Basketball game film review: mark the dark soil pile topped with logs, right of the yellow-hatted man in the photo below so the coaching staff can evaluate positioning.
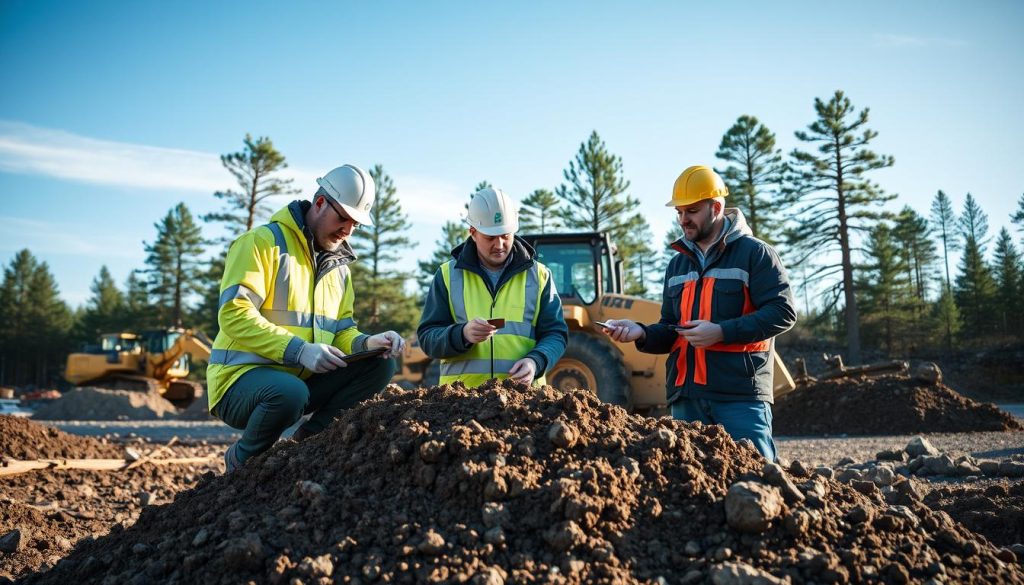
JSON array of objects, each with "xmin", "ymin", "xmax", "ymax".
[{"xmin": 772, "ymin": 376, "xmax": 1022, "ymax": 435}]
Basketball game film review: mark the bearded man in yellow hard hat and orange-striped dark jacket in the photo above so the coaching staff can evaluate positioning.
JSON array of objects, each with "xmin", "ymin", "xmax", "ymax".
[{"xmin": 593, "ymin": 165, "xmax": 797, "ymax": 460}]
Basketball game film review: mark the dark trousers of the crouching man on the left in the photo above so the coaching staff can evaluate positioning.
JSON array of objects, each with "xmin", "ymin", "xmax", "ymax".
[{"xmin": 212, "ymin": 359, "xmax": 395, "ymax": 464}]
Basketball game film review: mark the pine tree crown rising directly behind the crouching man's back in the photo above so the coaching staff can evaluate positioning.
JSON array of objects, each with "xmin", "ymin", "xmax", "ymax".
[{"xmin": 202, "ymin": 134, "xmax": 299, "ymax": 243}]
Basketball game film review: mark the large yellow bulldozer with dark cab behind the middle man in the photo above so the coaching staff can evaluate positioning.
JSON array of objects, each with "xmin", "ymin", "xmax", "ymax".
[{"xmin": 394, "ymin": 233, "xmax": 795, "ymax": 414}]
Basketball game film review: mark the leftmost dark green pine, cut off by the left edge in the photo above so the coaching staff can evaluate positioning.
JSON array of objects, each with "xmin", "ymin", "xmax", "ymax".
[{"xmin": 0, "ymin": 250, "xmax": 73, "ymax": 385}]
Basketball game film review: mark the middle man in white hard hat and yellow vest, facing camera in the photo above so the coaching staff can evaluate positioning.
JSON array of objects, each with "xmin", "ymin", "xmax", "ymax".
[{"xmin": 416, "ymin": 187, "xmax": 568, "ymax": 386}]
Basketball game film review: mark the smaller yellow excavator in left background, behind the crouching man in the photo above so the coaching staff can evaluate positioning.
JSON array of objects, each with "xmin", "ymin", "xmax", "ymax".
[{"xmin": 65, "ymin": 328, "xmax": 213, "ymax": 408}]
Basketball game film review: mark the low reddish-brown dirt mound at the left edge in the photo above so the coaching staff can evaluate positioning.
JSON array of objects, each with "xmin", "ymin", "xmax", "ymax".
[{"xmin": 0, "ymin": 415, "xmax": 124, "ymax": 459}]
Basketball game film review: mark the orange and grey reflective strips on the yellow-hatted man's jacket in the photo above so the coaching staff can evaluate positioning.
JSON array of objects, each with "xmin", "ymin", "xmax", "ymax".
[{"xmin": 669, "ymin": 268, "xmax": 771, "ymax": 386}]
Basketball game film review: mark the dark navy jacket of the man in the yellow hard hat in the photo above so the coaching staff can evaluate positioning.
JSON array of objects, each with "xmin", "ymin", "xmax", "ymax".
[{"xmin": 636, "ymin": 209, "xmax": 797, "ymax": 403}]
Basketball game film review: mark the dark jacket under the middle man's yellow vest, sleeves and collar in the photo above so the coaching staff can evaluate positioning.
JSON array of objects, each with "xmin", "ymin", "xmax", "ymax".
[{"xmin": 416, "ymin": 237, "xmax": 569, "ymax": 377}]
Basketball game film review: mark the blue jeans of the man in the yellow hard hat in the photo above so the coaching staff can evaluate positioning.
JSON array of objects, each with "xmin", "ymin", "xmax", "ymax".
[{"xmin": 672, "ymin": 399, "xmax": 778, "ymax": 461}]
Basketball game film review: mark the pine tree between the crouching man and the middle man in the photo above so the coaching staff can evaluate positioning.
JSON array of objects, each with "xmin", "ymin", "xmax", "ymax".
[{"xmin": 351, "ymin": 165, "xmax": 419, "ymax": 334}]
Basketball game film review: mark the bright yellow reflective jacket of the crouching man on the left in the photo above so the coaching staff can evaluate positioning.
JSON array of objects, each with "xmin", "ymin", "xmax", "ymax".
[{"xmin": 206, "ymin": 207, "xmax": 362, "ymax": 409}]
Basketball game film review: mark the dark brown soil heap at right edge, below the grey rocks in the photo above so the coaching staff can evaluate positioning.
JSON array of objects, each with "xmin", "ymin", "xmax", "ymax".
[{"xmin": 924, "ymin": 482, "xmax": 1024, "ymax": 546}]
